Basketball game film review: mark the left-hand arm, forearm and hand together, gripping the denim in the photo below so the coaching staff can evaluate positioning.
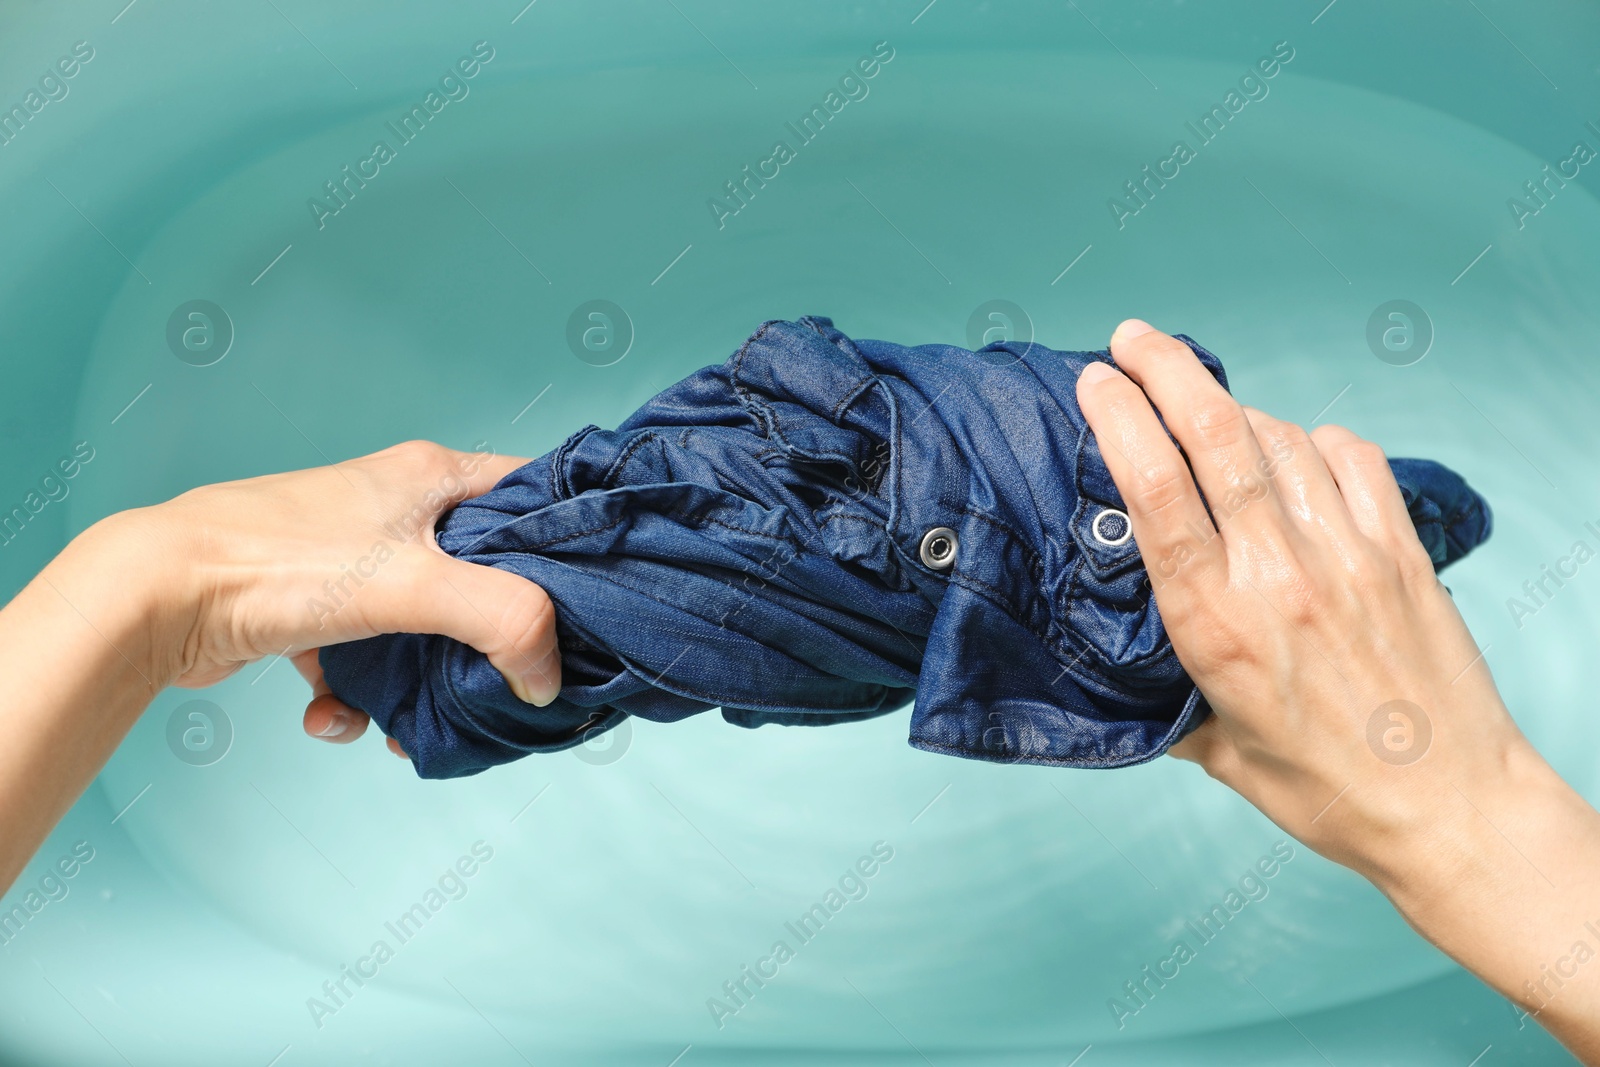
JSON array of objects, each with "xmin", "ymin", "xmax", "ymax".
[{"xmin": 0, "ymin": 442, "xmax": 560, "ymax": 891}]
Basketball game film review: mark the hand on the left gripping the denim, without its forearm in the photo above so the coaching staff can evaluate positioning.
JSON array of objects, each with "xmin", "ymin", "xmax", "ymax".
[{"xmin": 136, "ymin": 442, "xmax": 562, "ymax": 755}]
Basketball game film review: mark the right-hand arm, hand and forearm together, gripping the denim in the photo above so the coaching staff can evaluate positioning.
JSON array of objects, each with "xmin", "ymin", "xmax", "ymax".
[{"xmin": 1078, "ymin": 320, "xmax": 1600, "ymax": 1062}]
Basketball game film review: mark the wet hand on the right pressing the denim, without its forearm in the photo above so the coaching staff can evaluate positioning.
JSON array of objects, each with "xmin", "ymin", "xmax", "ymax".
[{"xmin": 1078, "ymin": 322, "xmax": 1526, "ymax": 869}]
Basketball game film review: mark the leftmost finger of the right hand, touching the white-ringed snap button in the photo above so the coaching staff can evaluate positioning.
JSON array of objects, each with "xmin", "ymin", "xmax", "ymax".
[{"xmin": 1078, "ymin": 362, "xmax": 1224, "ymax": 589}]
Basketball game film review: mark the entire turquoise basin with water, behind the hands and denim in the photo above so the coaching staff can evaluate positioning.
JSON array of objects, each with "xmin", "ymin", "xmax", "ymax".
[{"xmin": 0, "ymin": 0, "xmax": 1600, "ymax": 1067}]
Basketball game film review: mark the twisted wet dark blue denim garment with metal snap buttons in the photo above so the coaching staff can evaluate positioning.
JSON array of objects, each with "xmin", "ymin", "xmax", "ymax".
[{"xmin": 322, "ymin": 318, "xmax": 1491, "ymax": 777}]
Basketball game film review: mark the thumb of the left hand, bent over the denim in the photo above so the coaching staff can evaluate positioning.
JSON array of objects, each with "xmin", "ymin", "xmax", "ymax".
[{"xmin": 352, "ymin": 545, "xmax": 562, "ymax": 707}]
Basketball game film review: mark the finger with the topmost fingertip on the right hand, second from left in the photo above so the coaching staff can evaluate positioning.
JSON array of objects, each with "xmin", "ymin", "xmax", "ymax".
[{"xmin": 1110, "ymin": 318, "xmax": 1282, "ymax": 541}]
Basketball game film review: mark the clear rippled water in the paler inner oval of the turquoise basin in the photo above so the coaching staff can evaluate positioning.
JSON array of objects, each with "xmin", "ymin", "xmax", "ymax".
[{"xmin": 0, "ymin": 20, "xmax": 1600, "ymax": 1049}]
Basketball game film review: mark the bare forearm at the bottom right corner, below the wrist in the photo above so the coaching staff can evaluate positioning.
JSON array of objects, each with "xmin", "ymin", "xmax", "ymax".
[{"xmin": 1362, "ymin": 747, "xmax": 1600, "ymax": 1064}]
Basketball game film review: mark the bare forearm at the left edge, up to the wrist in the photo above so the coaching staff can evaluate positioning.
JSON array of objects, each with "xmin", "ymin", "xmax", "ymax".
[{"xmin": 0, "ymin": 515, "xmax": 174, "ymax": 891}]
